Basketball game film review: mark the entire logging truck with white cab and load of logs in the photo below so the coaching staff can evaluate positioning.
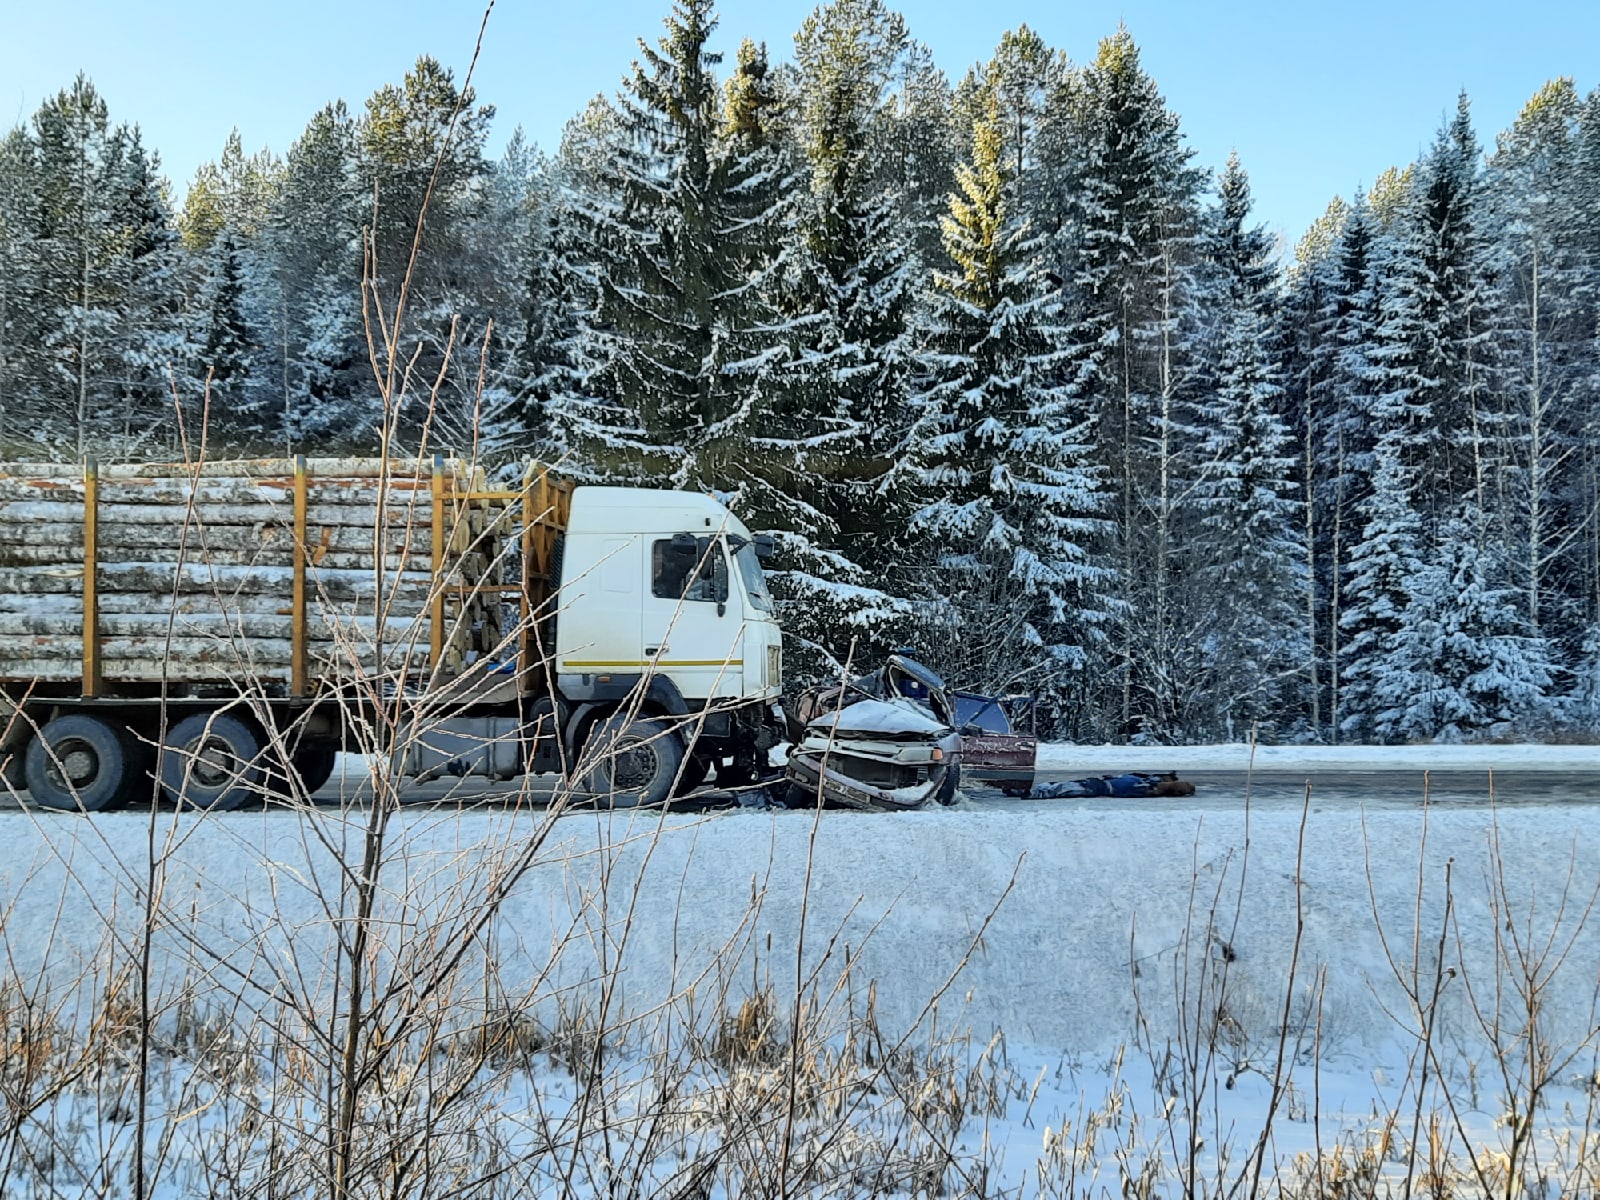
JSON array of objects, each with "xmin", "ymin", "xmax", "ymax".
[{"xmin": 0, "ymin": 458, "xmax": 782, "ymax": 811}]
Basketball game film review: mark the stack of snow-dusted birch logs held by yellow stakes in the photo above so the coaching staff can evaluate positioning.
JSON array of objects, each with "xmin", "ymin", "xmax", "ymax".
[{"xmin": 0, "ymin": 459, "xmax": 515, "ymax": 686}]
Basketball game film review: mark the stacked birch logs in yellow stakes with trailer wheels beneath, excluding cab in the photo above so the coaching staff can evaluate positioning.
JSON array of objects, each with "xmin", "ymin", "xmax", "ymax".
[{"xmin": 0, "ymin": 458, "xmax": 573, "ymax": 810}]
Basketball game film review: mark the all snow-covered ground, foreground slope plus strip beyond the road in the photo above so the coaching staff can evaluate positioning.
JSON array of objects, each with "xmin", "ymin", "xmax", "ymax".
[{"xmin": 0, "ymin": 747, "xmax": 1600, "ymax": 1197}]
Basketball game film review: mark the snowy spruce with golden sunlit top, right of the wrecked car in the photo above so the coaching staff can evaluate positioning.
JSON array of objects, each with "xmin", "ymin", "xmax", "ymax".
[{"xmin": 912, "ymin": 85, "xmax": 1099, "ymax": 702}]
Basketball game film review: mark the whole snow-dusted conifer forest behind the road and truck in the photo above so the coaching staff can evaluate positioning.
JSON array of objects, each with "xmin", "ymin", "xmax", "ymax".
[{"xmin": 0, "ymin": 0, "xmax": 1600, "ymax": 741}]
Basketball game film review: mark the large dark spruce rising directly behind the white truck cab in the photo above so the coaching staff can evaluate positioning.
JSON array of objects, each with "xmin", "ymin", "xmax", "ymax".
[{"xmin": 570, "ymin": 0, "xmax": 782, "ymax": 490}]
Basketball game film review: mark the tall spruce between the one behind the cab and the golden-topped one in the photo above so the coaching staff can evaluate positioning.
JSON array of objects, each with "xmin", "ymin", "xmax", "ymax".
[{"xmin": 763, "ymin": 0, "xmax": 917, "ymax": 677}]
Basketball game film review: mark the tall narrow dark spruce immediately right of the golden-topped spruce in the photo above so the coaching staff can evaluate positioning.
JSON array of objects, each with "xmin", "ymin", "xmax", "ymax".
[{"xmin": 1058, "ymin": 29, "xmax": 1200, "ymax": 738}]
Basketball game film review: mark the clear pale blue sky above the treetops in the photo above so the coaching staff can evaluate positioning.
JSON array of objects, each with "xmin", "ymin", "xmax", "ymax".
[{"xmin": 0, "ymin": 0, "xmax": 1600, "ymax": 243}]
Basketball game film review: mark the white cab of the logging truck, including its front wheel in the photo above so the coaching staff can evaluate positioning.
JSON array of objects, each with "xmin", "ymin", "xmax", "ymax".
[{"xmin": 492, "ymin": 486, "xmax": 782, "ymax": 805}]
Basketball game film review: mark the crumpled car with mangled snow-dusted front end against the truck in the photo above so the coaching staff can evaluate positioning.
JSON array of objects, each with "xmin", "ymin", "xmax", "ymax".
[{"xmin": 784, "ymin": 654, "xmax": 962, "ymax": 811}]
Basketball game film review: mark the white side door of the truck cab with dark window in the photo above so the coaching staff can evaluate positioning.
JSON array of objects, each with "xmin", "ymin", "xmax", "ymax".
[{"xmin": 643, "ymin": 533, "xmax": 744, "ymax": 699}]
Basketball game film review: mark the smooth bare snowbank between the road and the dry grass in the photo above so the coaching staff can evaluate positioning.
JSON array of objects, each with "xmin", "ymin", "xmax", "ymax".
[{"xmin": 0, "ymin": 802, "xmax": 1600, "ymax": 1053}]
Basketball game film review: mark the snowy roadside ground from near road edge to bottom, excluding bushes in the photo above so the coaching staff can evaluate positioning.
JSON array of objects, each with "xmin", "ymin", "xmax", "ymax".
[{"xmin": 0, "ymin": 780, "xmax": 1600, "ymax": 1197}]
